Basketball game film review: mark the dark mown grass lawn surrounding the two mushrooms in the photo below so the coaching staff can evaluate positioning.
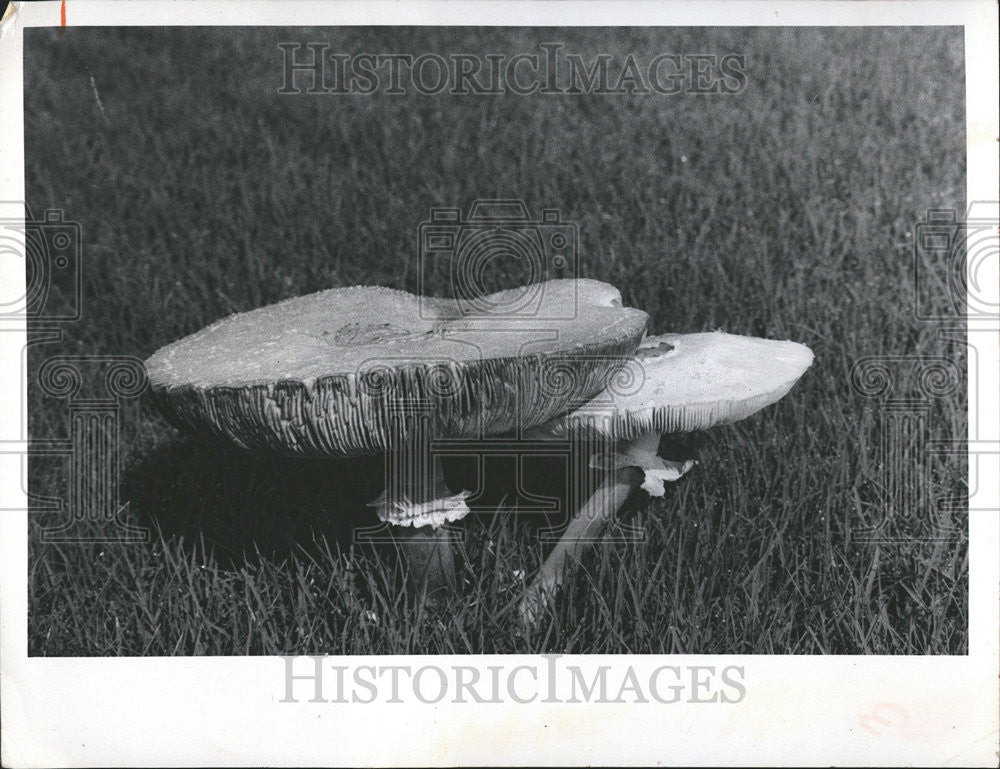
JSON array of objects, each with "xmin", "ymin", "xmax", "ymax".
[{"xmin": 25, "ymin": 28, "xmax": 968, "ymax": 655}]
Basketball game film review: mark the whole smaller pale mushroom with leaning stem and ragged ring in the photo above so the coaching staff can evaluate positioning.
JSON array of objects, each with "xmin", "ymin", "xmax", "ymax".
[{"xmin": 520, "ymin": 332, "xmax": 813, "ymax": 628}]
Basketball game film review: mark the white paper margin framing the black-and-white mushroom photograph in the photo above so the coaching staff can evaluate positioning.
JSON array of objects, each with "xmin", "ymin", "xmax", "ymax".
[{"xmin": 0, "ymin": 0, "xmax": 1000, "ymax": 767}]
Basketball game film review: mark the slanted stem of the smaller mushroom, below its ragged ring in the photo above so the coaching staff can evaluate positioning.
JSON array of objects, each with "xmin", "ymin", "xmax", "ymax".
[{"xmin": 520, "ymin": 467, "xmax": 643, "ymax": 628}]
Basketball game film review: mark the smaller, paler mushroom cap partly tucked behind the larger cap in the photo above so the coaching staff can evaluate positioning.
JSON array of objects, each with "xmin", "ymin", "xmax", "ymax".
[{"xmin": 539, "ymin": 332, "xmax": 813, "ymax": 440}]
